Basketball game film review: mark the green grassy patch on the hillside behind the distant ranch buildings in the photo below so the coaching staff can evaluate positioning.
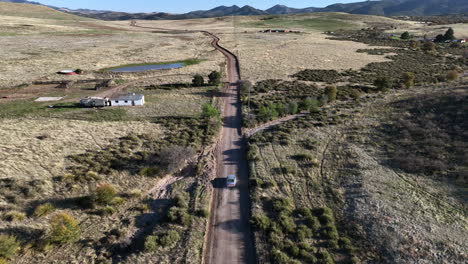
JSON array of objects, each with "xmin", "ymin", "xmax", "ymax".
[{"xmin": 243, "ymin": 15, "xmax": 356, "ymax": 31}]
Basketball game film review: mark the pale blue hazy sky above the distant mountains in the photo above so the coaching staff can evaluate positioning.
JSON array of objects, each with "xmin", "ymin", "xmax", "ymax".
[{"xmin": 33, "ymin": 0, "xmax": 362, "ymax": 13}]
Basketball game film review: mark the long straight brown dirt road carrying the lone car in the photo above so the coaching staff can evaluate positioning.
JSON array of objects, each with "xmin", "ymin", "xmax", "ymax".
[{"xmin": 205, "ymin": 32, "xmax": 255, "ymax": 264}]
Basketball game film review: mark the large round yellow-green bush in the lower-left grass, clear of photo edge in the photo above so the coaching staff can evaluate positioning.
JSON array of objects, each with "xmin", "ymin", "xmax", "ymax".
[{"xmin": 49, "ymin": 213, "xmax": 81, "ymax": 244}]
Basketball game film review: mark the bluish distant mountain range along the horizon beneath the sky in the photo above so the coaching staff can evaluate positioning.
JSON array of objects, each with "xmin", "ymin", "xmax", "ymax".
[{"xmin": 0, "ymin": 0, "xmax": 468, "ymax": 20}]
